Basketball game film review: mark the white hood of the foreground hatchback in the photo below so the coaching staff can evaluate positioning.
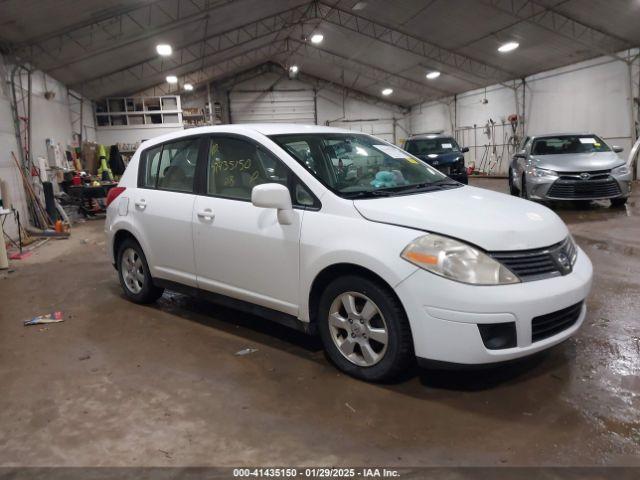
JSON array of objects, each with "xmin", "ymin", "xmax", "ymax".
[{"xmin": 354, "ymin": 186, "xmax": 568, "ymax": 251}]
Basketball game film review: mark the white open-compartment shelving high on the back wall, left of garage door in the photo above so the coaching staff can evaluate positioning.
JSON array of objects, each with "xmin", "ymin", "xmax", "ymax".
[{"xmin": 96, "ymin": 95, "xmax": 183, "ymax": 127}]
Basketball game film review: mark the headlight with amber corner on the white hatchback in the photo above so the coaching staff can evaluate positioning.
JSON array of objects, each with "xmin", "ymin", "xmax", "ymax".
[{"xmin": 400, "ymin": 233, "xmax": 520, "ymax": 285}]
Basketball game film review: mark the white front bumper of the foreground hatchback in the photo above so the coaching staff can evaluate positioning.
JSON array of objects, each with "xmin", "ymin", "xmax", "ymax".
[{"xmin": 395, "ymin": 249, "xmax": 593, "ymax": 365}]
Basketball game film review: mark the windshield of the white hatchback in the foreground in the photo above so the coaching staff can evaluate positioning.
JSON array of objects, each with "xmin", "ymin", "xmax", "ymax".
[{"xmin": 270, "ymin": 133, "xmax": 452, "ymax": 197}]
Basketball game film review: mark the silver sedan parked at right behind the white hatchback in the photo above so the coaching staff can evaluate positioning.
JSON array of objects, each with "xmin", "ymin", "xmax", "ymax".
[{"xmin": 509, "ymin": 133, "xmax": 631, "ymax": 206}]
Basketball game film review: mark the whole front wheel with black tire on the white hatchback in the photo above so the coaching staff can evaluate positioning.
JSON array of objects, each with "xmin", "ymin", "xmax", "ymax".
[{"xmin": 318, "ymin": 275, "xmax": 414, "ymax": 382}]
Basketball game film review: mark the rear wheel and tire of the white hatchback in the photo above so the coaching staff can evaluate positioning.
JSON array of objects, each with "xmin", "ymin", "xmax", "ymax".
[{"xmin": 116, "ymin": 238, "xmax": 164, "ymax": 304}]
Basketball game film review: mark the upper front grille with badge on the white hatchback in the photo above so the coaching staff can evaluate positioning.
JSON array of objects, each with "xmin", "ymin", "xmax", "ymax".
[{"xmin": 490, "ymin": 237, "xmax": 576, "ymax": 282}]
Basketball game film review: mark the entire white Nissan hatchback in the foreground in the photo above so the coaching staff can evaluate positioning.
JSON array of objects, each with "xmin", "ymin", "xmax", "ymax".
[{"xmin": 106, "ymin": 124, "xmax": 592, "ymax": 380}]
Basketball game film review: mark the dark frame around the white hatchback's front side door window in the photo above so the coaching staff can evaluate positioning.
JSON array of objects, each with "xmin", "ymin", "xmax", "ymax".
[{"xmin": 195, "ymin": 132, "xmax": 322, "ymax": 211}]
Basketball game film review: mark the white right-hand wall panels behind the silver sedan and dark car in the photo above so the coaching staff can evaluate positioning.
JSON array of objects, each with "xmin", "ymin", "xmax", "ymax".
[{"xmin": 408, "ymin": 50, "xmax": 640, "ymax": 175}]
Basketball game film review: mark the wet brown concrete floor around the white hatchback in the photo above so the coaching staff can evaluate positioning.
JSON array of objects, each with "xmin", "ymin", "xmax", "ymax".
[{"xmin": 0, "ymin": 180, "xmax": 640, "ymax": 466}]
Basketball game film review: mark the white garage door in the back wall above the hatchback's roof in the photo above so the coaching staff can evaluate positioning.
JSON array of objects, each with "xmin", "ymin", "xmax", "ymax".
[{"xmin": 230, "ymin": 90, "xmax": 316, "ymax": 124}]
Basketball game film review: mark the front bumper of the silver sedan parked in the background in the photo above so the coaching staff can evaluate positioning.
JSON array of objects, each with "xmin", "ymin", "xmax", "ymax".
[{"xmin": 526, "ymin": 173, "xmax": 632, "ymax": 201}]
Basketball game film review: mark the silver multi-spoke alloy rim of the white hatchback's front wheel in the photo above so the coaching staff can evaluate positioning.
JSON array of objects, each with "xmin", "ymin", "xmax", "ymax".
[{"xmin": 328, "ymin": 292, "xmax": 389, "ymax": 367}]
